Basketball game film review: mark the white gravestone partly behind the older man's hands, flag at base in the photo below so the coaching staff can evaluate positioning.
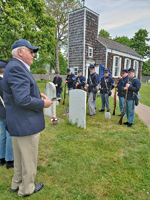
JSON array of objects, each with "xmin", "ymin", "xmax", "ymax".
[{"xmin": 44, "ymin": 82, "xmax": 56, "ymax": 118}]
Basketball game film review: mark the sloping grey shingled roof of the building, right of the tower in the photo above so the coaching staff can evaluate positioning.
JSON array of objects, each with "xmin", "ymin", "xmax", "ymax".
[{"xmin": 98, "ymin": 36, "xmax": 143, "ymax": 58}]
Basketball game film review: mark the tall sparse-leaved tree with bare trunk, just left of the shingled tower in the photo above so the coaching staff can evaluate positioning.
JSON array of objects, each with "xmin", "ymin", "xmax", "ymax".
[{"xmin": 43, "ymin": 0, "xmax": 82, "ymax": 71}]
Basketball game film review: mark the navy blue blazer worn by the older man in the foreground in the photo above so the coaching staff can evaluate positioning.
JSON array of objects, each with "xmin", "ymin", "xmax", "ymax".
[{"xmin": 3, "ymin": 58, "xmax": 45, "ymax": 136}]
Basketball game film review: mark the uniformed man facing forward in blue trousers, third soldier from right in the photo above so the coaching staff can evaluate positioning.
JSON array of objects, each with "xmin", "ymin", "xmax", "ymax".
[{"xmin": 99, "ymin": 68, "xmax": 114, "ymax": 112}]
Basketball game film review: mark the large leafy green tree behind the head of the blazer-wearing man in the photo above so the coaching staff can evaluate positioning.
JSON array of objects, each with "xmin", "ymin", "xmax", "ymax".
[{"xmin": 0, "ymin": 0, "xmax": 55, "ymax": 65}]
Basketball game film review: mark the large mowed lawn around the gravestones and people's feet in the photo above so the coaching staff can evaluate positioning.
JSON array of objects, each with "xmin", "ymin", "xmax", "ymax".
[{"xmin": 0, "ymin": 83, "xmax": 150, "ymax": 200}]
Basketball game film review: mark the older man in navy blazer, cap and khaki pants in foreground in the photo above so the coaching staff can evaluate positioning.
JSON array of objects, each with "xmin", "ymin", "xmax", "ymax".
[{"xmin": 3, "ymin": 39, "xmax": 52, "ymax": 196}]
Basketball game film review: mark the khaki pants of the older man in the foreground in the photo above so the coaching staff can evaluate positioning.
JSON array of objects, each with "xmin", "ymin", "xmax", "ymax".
[{"xmin": 11, "ymin": 133, "xmax": 40, "ymax": 196}]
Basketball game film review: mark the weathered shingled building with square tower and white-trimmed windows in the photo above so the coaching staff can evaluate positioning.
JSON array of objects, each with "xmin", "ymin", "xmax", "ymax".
[{"xmin": 68, "ymin": 7, "xmax": 143, "ymax": 80}]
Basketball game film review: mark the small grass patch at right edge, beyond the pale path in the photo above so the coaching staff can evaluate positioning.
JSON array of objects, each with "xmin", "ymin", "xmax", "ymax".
[{"xmin": 139, "ymin": 82, "xmax": 150, "ymax": 106}]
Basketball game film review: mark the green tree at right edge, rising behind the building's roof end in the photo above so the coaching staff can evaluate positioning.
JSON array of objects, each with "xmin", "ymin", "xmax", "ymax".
[{"xmin": 131, "ymin": 29, "xmax": 150, "ymax": 58}]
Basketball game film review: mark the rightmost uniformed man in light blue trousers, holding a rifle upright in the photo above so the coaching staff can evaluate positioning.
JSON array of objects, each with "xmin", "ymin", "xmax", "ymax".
[{"xmin": 123, "ymin": 68, "xmax": 141, "ymax": 127}]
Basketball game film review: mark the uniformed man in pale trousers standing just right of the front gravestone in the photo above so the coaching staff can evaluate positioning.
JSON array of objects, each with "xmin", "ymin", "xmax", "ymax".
[{"xmin": 85, "ymin": 64, "xmax": 98, "ymax": 117}]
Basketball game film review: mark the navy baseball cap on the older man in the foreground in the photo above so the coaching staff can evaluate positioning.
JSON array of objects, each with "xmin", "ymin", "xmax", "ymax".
[{"xmin": 12, "ymin": 39, "xmax": 39, "ymax": 53}]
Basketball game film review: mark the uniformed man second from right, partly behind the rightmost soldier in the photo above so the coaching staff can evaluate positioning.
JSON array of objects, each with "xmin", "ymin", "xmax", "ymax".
[{"xmin": 115, "ymin": 69, "xmax": 129, "ymax": 116}]
